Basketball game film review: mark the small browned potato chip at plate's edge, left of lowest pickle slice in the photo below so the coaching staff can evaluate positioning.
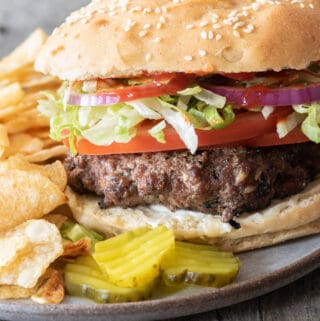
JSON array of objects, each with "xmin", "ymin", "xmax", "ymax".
[{"xmin": 31, "ymin": 268, "xmax": 64, "ymax": 304}]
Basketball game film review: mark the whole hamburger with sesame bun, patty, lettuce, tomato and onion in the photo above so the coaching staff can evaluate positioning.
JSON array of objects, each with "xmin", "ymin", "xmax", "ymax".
[{"xmin": 36, "ymin": 0, "xmax": 320, "ymax": 251}]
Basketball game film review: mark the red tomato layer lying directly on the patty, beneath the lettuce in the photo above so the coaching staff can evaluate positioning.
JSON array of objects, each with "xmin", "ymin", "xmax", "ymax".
[{"xmin": 63, "ymin": 107, "xmax": 292, "ymax": 155}]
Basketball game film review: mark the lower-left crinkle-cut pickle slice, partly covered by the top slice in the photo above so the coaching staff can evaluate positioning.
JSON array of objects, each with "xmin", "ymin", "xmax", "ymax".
[{"xmin": 64, "ymin": 256, "xmax": 157, "ymax": 303}]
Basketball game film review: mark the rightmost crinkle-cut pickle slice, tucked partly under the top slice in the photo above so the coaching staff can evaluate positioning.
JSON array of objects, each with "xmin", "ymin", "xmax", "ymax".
[{"xmin": 161, "ymin": 242, "xmax": 240, "ymax": 287}]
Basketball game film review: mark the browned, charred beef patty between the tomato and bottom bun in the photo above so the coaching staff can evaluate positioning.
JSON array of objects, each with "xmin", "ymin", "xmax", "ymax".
[{"xmin": 65, "ymin": 143, "xmax": 320, "ymax": 222}]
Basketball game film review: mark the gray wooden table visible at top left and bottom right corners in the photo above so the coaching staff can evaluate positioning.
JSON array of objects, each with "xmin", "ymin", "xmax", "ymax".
[{"xmin": 0, "ymin": 0, "xmax": 320, "ymax": 321}]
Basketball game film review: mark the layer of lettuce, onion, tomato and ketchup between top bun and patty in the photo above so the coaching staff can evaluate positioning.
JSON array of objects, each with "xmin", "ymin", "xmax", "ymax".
[{"xmin": 39, "ymin": 63, "xmax": 320, "ymax": 154}]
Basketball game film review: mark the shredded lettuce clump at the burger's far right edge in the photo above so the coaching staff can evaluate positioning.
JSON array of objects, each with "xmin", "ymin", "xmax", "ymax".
[{"xmin": 293, "ymin": 102, "xmax": 320, "ymax": 144}]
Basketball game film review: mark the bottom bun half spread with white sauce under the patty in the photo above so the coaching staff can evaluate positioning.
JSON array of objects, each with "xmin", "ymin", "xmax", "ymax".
[{"xmin": 66, "ymin": 178, "xmax": 320, "ymax": 252}]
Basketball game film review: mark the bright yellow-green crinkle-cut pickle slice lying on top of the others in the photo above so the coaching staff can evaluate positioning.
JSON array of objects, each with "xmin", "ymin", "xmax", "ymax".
[{"xmin": 93, "ymin": 226, "xmax": 175, "ymax": 288}]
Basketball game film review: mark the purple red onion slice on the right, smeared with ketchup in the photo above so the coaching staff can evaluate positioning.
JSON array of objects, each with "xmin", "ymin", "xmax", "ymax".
[{"xmin": 202, "ymin": 83, "xmax": 320, "ymax": 107}]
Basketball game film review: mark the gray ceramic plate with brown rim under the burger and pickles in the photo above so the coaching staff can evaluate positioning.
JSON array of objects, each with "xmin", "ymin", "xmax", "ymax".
[{"xmin": 0, "ymin": 235, "xmax": 320, "ymax": 321}]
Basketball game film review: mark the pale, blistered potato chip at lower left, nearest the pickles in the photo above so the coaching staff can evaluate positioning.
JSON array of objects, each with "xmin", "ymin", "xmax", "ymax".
[{"xmin": 0, "ymin": 220, "xmax": 63, "ymax": 288}]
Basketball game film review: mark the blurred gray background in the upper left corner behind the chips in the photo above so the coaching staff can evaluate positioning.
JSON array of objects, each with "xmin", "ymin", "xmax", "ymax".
[{"xmin": 0, "ymin": 0, "xmax": 90, "ymax": 57}]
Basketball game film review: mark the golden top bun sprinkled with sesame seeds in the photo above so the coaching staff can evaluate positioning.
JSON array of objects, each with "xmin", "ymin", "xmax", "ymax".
[{"xmin": 36, "ymin": 0, "xmax": 320, "ymax": 81}]
